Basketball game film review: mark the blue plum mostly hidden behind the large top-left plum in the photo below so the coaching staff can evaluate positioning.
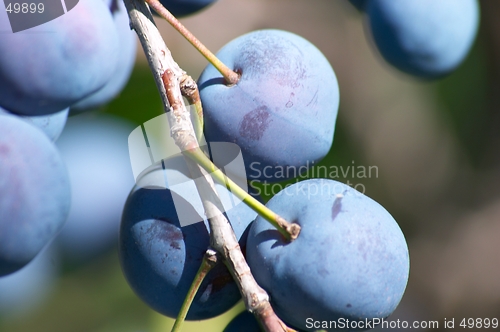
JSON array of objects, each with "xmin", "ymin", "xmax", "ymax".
[{"xmin": 71, "ymin": 0, "xmax": 137, "ymax": 113}]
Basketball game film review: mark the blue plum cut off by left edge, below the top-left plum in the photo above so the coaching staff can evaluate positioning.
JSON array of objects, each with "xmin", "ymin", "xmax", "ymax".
[{"xmin": 0, "ymin": 115, "xmax": 71, "ymax": 276}]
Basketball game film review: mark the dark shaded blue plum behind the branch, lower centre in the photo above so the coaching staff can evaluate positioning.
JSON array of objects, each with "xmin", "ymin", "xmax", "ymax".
[{"xmin": 119, "ymin": 157, "xmax": 257, "ymax": 320}]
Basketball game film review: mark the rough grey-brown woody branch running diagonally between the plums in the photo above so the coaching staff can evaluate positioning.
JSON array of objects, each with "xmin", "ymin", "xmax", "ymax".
[{"xmin": 124, "ymin": 0, "xmax": 293, "ymax": 332}]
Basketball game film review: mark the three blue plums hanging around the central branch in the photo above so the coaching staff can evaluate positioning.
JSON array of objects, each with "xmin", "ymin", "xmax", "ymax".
[{"xmin": 120, "ymin": 3, "xmax": 409, "ymax": 330}]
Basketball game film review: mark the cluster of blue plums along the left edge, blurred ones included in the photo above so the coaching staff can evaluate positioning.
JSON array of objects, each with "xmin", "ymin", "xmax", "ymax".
[{"xmin": 0, "ymin": 0, "xmax": 217, "ymax": 318}]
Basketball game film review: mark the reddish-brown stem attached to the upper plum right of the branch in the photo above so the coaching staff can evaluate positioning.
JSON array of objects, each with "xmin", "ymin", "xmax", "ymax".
[{"xmin": 145, "ymin": 0, "xmax": 240, "ymax": 85}]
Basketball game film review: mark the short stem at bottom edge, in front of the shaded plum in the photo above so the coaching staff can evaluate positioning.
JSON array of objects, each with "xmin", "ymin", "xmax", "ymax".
[{"xmin": 172, "ymin": 249, "xmax": 218, "ymax": 332}]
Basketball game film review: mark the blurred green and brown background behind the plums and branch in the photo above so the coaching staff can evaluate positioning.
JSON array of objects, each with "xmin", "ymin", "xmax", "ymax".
[{"xmin": 0, "ymin": 0, "xmax": 500, "ymax": 332}]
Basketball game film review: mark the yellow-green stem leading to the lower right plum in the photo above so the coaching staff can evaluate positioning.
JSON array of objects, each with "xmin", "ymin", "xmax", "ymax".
[{"xmin": 184, "ymin": 148, "xmax": 300, "ymax": 241}]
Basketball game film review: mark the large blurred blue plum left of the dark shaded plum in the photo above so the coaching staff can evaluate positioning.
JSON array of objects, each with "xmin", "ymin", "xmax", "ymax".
[{"xmin": 55, "ymin": 113, "xmax": 134, "ymax": 264}]
